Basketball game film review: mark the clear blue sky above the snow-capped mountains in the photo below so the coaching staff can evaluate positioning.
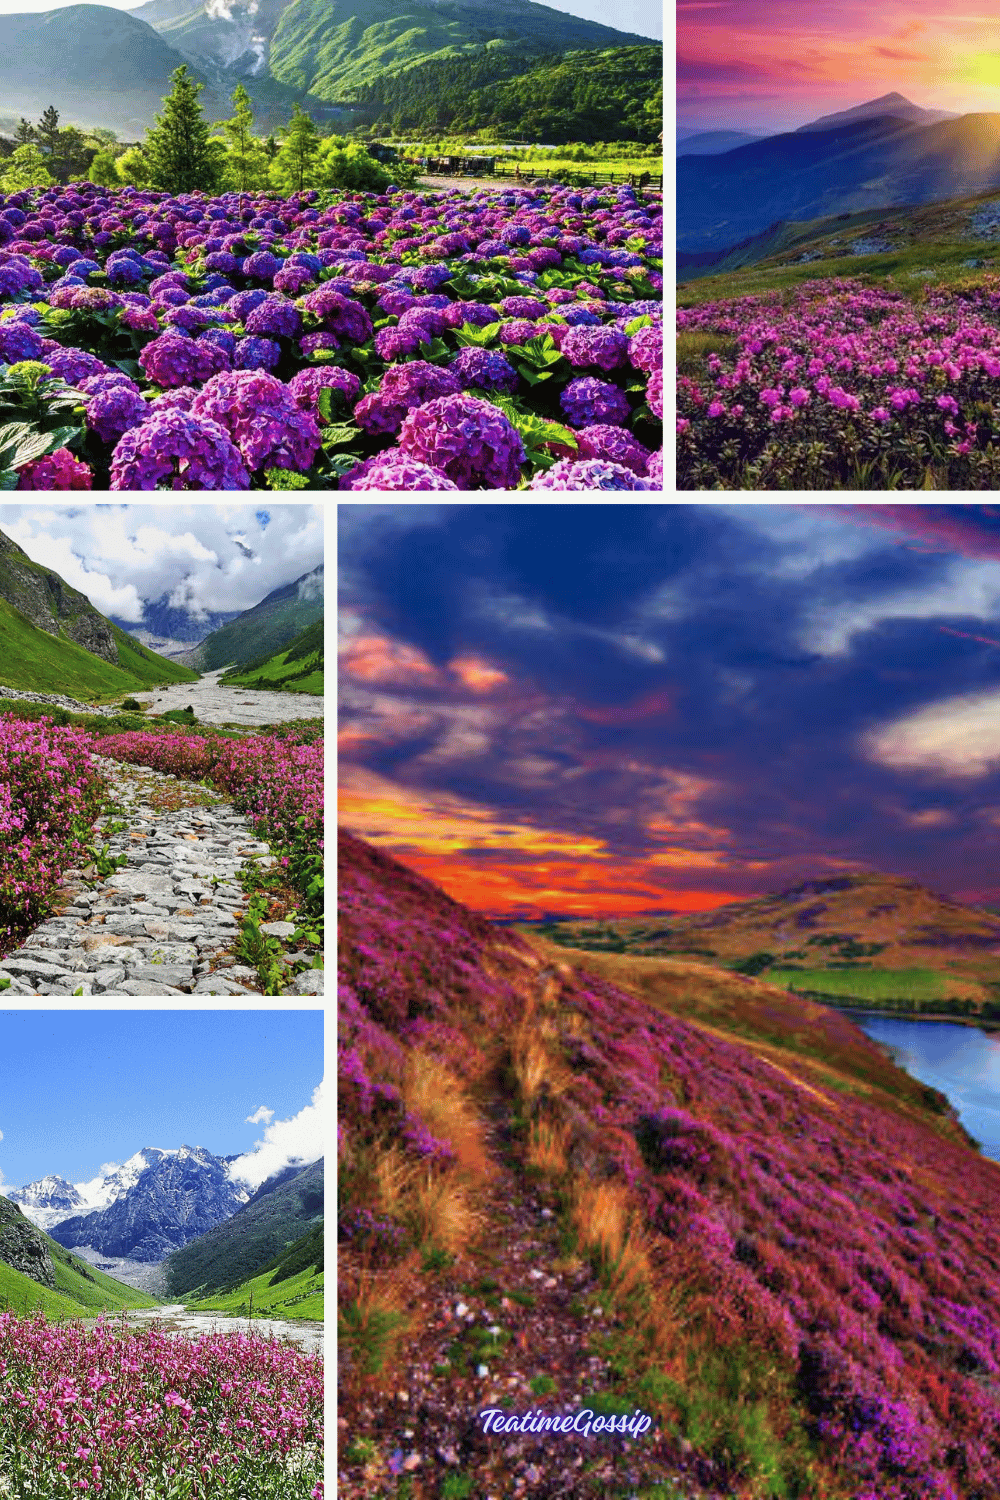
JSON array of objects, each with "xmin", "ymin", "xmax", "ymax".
[{"xmin": 0, "ymin": 1011, "xmax": 322, "ymax": 1187}]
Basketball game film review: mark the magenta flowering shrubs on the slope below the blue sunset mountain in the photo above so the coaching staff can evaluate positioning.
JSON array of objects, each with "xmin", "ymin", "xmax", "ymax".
[{"xmin": 678, "ymin": 276, "xmax": 1000, "ymax": 491}]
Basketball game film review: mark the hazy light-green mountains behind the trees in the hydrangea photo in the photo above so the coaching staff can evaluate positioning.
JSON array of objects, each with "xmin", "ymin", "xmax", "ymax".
[{"xmin": 0, "ymin": 0, "xmax": 649, "ymax": 138}]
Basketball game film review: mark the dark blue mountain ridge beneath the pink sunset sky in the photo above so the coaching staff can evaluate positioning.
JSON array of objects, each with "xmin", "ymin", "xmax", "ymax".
[{"xmin": 678, "ymin": 96, "xmax": 1000, "ymax": 252}]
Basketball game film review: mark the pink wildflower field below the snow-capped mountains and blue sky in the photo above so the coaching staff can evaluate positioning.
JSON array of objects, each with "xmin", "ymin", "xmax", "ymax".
[{"xmin": 0, "ymin": 1313, "xmax": 324, "ymax": 1500}]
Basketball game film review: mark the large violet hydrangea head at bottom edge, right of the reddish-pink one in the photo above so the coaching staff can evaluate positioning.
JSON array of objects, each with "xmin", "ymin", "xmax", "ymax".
[{"xmin": 109, "ymin": 407, "xmax": 250, "ymax": 489}]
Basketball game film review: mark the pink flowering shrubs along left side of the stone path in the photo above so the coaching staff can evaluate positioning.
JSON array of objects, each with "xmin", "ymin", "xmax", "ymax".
[{"xmin": 0, "ymin": 717, "xmax": 103, "ymax": 954}]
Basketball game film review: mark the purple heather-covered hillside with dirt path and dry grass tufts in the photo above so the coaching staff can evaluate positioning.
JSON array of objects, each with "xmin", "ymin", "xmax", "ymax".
[{"xmin": 339, "ymin": 834, "xmax": 1000, "ymax": 1500}]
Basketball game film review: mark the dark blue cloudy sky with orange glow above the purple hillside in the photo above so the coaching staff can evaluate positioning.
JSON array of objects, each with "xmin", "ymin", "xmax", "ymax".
[{"xmin": 339, "ymin": 504, "xmax": 1000, "ymax": 917}]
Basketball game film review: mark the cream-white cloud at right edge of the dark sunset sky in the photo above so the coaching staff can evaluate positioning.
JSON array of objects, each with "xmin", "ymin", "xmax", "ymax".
[{"xmin": 862, "ymin": 690, "xmax": 1000, "ymax": 777}]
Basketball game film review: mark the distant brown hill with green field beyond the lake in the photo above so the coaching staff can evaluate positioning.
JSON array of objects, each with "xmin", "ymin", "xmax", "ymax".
[{"xmin": 523, "ymin": 875, "xmax": 1000, "ymax": 1016}]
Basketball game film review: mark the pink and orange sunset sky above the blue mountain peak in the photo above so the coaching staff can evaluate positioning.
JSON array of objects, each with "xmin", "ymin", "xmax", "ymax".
[{"xmin": 678, "ymin": 0, "xmax": 1000, "ymax": 132}]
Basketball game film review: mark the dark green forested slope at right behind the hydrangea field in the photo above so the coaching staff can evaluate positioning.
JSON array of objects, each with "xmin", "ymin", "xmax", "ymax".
[{"xmin": 344, "ymin": 47, "xmax": 663, "ymax": 146}]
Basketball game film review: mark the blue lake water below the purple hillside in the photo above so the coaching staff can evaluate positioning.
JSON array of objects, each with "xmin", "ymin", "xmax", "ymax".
[{"xmin": 853, "ymin": 1014, "xmax": 1000, "ymax": 1161}]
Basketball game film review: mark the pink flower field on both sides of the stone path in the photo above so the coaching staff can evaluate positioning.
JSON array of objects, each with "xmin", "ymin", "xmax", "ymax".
[{"xmin": 0, "ymin": 716, "xmax": 322, "ymax": 956}]
